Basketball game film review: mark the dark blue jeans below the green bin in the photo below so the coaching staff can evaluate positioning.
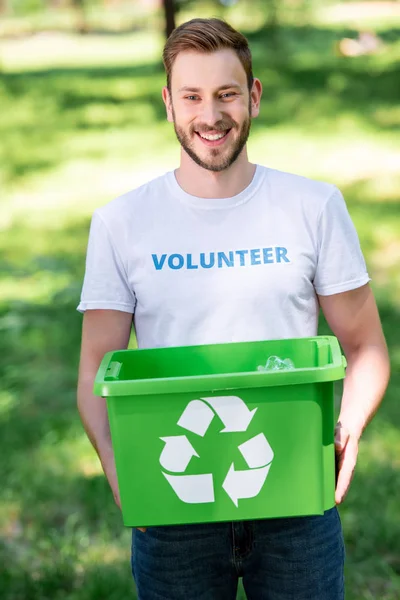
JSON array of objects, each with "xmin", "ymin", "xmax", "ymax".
[{"xmin": 132, "ymin": 507, "xmax": 344, "ymax": 600}]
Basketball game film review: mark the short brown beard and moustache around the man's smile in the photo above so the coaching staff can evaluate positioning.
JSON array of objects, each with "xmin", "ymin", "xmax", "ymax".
[{"xmin": 172, "ymin": 106, "xmax": 251, "ymax": 172}]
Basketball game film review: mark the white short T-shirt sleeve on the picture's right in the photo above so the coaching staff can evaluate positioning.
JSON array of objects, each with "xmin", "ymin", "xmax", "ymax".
[{"xmin": 314, "ymin": 188, "xmax": 370, "ymax": 296}]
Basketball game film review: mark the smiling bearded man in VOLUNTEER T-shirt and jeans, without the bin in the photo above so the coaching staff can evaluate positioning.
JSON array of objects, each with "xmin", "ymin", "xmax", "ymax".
[{"xmin": 78, "ymin": 19, "xmax": 389, "ymax": 600}]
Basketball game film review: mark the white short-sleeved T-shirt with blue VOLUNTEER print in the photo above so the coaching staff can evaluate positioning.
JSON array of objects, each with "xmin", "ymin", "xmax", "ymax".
[{"xmin": 78, "ymin": 166, "xmax": 369, "ymax": 348}]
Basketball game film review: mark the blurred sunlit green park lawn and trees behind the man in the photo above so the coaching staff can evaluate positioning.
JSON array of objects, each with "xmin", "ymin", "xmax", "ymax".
[{"xmin": 0, "ymin": 0, "xmax": 400, "ymax": 600}]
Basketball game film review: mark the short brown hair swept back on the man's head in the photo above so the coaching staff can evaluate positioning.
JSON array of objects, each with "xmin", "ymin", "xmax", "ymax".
[{"xmin": 163, "ymin": 19, "xmax": 253, "ymax": 90}]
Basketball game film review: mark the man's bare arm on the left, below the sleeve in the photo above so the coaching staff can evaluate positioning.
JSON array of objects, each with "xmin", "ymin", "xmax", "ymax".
[{"xmin": 78, "ymin": 310, "xmax": 132, "ymax": 506}]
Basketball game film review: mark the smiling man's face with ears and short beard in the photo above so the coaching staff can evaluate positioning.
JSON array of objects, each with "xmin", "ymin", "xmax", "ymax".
[{"xmin": 163, "ymin": 49, "xmax": 258, "ymax": 171}]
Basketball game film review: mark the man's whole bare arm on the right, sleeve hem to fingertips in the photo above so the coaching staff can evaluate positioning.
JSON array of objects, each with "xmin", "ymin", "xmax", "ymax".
[{"xmin": 319, "ymin": 284, "xmax": 390, "ymax": 504}]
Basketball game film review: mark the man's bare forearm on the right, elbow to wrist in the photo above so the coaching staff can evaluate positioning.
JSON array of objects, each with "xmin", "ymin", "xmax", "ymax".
[{"xmin": 339, "ymin": 340, "xmax": 390, "ymax": 438}]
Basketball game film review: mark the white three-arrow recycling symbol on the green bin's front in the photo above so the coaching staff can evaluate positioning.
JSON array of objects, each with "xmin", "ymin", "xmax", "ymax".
[{"xmin": 160, "ymin": 396, "xmax": 274, "ymax": 506}]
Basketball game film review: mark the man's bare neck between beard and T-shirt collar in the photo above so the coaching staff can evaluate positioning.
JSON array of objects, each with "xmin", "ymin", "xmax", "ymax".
[{"xmin": 175, "ymin": 149, "xmax": 256, "ymax": 198}]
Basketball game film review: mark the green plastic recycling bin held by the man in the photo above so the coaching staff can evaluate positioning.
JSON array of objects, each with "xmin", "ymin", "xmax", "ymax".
[{"xmin": 94, "ymin": 336, "xmax": 346, "ymax": 527}]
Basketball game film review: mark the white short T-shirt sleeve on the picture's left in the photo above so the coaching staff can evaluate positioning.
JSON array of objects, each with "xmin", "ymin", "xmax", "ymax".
[{"xmin": 77, "ymin": 212, "xmax": 135, "ymax": 313}]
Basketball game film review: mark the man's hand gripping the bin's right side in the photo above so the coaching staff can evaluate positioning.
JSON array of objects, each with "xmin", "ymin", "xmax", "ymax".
[{"xmin": 335, "ymin": 421, "xmax": 358, "ymax": 504}]
